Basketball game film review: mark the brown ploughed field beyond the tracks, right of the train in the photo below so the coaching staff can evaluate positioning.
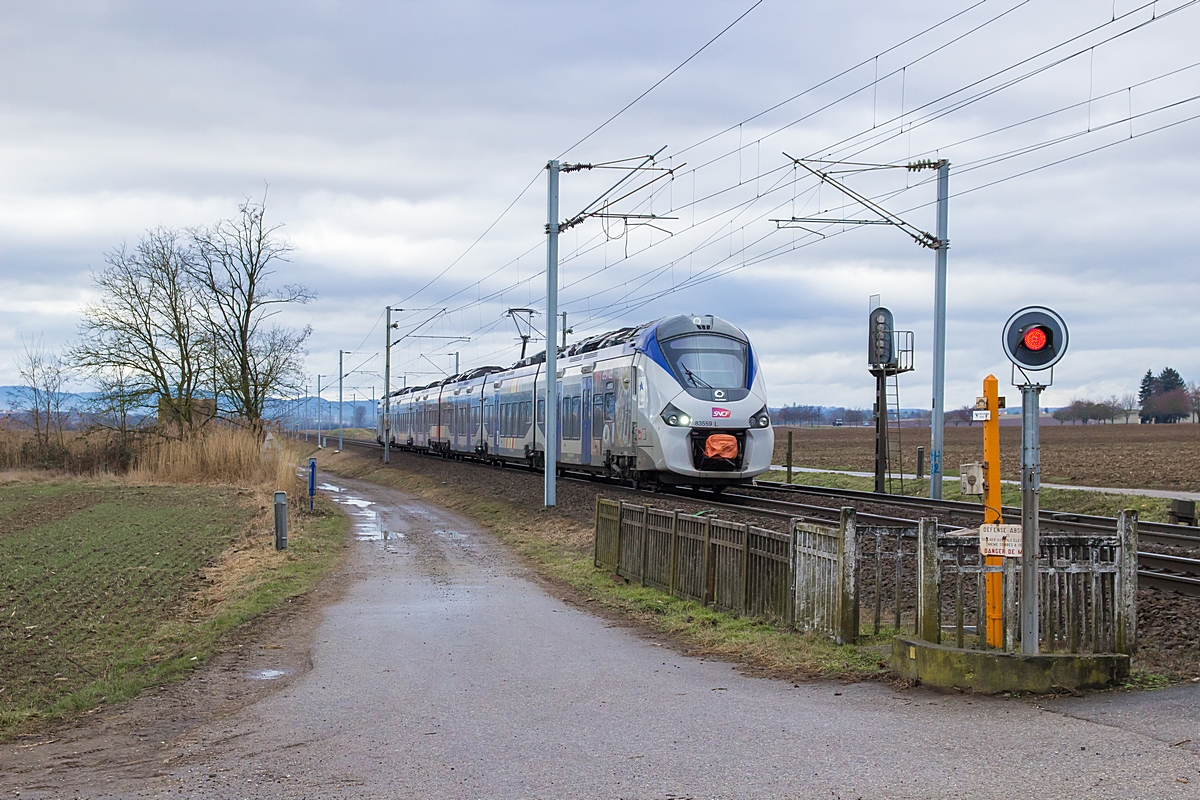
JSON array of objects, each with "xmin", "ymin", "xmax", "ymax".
[{"xmin": 774, "ymin": 422, "xmax": 1200, "ymax": 492}]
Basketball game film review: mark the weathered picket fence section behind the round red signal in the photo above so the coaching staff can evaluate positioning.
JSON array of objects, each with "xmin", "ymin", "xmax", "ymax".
[{"xmin": 917, "ymin": 511, "xmax": 1138, "ymax": 655}]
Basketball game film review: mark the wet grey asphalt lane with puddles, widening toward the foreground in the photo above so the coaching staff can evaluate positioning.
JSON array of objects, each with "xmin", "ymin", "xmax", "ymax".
[{"xmin": 138, "ymin": 479, "xmax": 1200, "ymax": 799}]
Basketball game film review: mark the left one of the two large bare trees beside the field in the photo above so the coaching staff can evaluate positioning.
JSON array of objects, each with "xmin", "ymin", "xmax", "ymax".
[{"xmin": 71, "ymin": 228, "xmax": 211, "ymax": 435}]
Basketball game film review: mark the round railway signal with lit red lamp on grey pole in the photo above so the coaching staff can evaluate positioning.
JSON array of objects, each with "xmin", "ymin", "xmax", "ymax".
[{"xmin": 1001, "ymin": 306, "xmax": 1069, "ymax": 655}]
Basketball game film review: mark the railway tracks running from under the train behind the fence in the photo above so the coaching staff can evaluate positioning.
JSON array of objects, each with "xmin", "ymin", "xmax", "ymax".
[{"xmin": 333, "ymin": 439, "xmax": 1200, "ymax": 596}]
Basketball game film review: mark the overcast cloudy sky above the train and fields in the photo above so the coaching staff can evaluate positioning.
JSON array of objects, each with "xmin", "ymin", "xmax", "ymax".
[{"xmin": 0, "ymin": 0, "xmax": 1200, "ymax": 408}]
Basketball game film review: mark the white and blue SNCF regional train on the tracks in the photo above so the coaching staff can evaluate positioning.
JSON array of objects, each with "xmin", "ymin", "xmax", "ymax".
[{"xmin": 377, "ymin": 315, "xmax": 775, "ymax": 491}]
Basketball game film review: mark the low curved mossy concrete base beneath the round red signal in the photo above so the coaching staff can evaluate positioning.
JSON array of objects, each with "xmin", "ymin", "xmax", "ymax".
[{"xmin": 892, "ymin": 636, "xmax": 1129, "ymax": 694}]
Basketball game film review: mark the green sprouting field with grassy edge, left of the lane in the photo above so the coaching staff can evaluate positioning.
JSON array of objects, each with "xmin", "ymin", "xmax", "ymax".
[{"xmin": 0, "ymin": 481, "xmax": 346, "ymax": 738}]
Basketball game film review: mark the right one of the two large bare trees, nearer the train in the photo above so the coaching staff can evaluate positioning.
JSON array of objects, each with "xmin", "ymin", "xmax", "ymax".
[{"xmin": 192, "ymin": 196, "xmax": 313, "ymax": 433}]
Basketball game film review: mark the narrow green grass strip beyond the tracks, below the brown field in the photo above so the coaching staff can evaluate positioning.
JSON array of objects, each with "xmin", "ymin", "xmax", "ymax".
[{"xmin": 762, "ymin": 470, "xmax": 1171, "ymax": 522}]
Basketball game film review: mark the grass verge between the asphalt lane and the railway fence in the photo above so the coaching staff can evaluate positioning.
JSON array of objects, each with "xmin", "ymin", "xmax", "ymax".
[{"xmin": 318, "ymin": 451, "xmax": 892, "ymax": 680}]
